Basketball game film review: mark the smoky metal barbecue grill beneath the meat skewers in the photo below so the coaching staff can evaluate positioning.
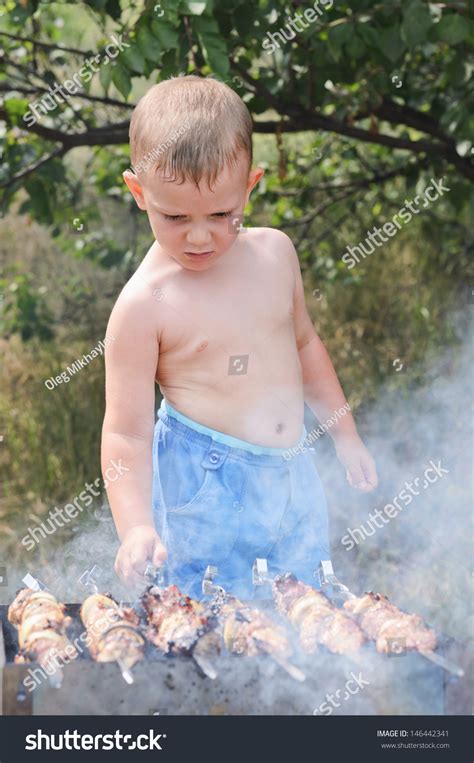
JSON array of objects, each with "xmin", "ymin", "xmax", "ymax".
[{"xmin": 0, "ymin": 560, "xmax": 472, "ymax": 715}]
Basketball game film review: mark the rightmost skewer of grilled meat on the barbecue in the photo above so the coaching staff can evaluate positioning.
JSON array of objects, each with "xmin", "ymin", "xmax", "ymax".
[{"xmin": 344, "ymin": 591, "xmax": 436, "ymax": 652}]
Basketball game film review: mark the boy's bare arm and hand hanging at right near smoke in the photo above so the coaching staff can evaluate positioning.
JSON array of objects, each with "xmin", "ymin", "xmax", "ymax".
[{"xmin": 288, "ymin": 239, "xmax": 378, "ymax": 492}]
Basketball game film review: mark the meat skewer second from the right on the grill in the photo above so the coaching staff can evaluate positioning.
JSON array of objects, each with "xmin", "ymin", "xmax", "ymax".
[{"xmin": 272, "ymin": 573, "xmax": 364, "ymax": 654}]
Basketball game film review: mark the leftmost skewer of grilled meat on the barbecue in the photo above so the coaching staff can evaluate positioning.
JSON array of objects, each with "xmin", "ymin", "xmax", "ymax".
[{"xmin": 8, "ymin": 588, "xmax": 77, "ymax": 669}]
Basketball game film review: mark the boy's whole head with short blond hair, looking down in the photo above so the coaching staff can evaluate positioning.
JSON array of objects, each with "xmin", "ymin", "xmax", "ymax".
[{"xmin": 124, "ymin": 75, "xmax": 263, "ymax": 270}]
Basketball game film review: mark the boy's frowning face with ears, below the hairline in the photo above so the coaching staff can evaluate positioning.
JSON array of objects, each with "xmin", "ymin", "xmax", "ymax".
[{"xmin": 123, "ymin": 156, "xmax": 263, "ymax": 271}]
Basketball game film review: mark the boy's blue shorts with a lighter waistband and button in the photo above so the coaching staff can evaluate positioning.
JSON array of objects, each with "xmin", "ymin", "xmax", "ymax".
[{"xmin": 153, "ymin": 400, "xmax": 330, "ymax": 599}]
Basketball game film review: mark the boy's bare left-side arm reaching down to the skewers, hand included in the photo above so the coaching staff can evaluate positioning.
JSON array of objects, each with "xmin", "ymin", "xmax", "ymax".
[{"xmin": 101, "ymin": 285, "xmax": 166, "ymax": 582}]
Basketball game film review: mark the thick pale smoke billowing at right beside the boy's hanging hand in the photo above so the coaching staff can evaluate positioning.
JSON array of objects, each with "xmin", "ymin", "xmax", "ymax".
[{"xmin": 319, "ymin": 314, "xmax": 473, "ymax": 641}]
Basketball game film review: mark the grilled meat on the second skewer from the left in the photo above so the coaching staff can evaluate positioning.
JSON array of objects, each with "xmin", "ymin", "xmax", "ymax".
[{"xmin": 81, "ymin": 593, "xmax": 145, "ymax": 670}]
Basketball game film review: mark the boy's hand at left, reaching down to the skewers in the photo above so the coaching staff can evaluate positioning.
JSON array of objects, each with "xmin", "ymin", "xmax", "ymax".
[{"xmin": 115, "ymin": 525, "xmax": 168, "ymax": 585}]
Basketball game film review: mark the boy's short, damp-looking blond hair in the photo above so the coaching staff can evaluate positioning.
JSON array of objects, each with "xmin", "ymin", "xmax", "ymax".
[{"xmin": 130, "ymin": 74, "xmax": 252, "ymax": 187}]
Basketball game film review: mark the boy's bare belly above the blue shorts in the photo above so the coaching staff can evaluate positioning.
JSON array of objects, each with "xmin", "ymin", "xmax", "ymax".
[{"xmin": 158, "ymin": 330, "xmax": 304, "ymax": 448}]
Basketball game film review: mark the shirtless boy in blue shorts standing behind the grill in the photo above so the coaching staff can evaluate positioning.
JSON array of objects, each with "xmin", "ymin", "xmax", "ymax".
[{"xmin": 102, "ymin": 76, "xmax": 377, "ymax": 598}]
